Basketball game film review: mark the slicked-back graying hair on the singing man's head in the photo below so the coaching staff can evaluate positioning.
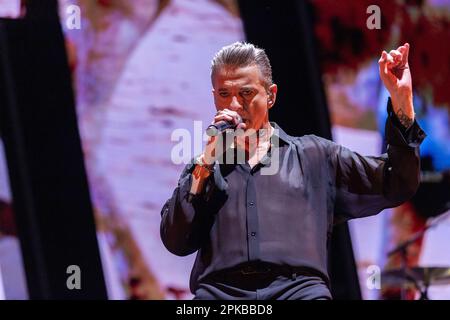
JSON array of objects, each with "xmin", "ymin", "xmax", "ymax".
[{"xmin": 211, "ymin": 42, "xmax": 273, "ymax": 89}]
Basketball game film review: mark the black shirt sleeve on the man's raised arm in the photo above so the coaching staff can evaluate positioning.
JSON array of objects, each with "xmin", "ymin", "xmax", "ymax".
[{"xmin": 330, "ymin": 99, "xmax": 426, "ymax": 222}]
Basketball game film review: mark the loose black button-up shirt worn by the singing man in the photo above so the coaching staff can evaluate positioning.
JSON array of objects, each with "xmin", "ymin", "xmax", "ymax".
[{"xmin": 161, "ymin": 100, "xmax": 425, "ymax": 292}]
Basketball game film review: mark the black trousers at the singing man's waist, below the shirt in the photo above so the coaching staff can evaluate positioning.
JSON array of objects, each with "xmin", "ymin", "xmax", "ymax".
[{"xmin": 194, "ymin": 273, "xmax": 332, "ymax": 300}]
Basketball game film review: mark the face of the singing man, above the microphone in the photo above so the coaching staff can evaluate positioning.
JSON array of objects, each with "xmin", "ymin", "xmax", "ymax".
[{"xmin": 213, "ymin": 65, "xmax": 277, "ymax": 130}]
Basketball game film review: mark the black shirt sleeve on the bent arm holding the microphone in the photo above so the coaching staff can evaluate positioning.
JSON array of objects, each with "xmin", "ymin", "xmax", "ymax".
[{"xmin": 160, "ymin": 161, "xmax": 227, "ymax": 256}]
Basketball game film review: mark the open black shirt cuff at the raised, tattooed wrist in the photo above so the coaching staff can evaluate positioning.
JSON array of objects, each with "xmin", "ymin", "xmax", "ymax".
[{"xmin": 385, "ymin": 98, "xmax": 427, "ymax": 148}]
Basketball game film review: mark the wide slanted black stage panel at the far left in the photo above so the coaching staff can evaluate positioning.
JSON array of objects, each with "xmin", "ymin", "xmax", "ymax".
[{"xmin": 0, "ymin": 0, "xmax": 107, "ymax": 299}]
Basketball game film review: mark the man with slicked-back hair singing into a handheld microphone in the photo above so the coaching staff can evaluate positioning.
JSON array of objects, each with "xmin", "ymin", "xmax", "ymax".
[{"xmin": 161, "ymin": 42, "xmax": 425, "ymax": 300}]
